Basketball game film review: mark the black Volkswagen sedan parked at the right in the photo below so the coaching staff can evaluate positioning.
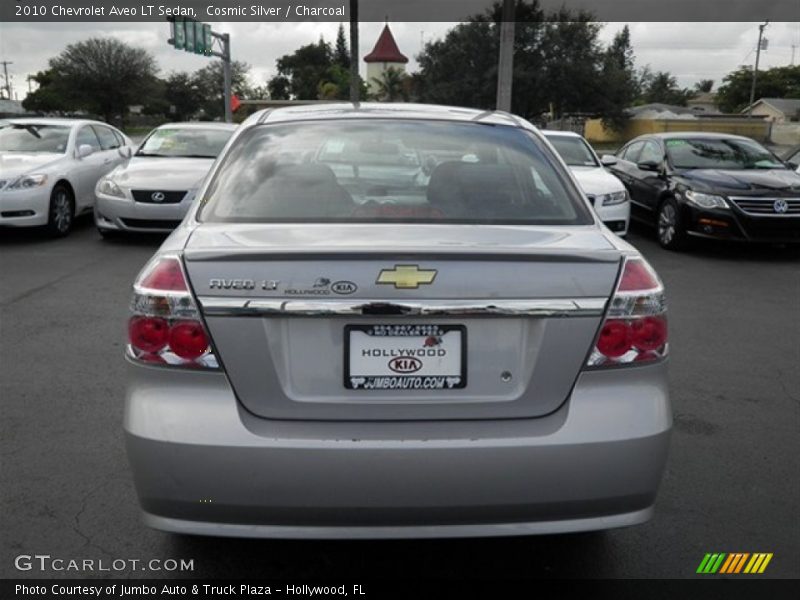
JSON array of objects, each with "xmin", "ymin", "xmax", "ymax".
[{"xmin": 611, "ymin": 132, "xmax": 800, "ymax": 250}]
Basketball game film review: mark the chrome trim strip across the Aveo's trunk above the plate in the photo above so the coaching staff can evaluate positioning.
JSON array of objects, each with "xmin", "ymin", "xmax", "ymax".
[{"xmin": 198, "ymin": 296, "xmax": 608, "ymax": 318}]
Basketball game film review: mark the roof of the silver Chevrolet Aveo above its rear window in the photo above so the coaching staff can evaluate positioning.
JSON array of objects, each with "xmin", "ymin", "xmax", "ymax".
[{"xmin": 246, "ymin": 102, "xmax": 535, "ymax": 129}]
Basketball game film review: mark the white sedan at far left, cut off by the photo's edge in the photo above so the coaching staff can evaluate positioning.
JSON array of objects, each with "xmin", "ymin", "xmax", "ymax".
[{"xmin": 0, "ymin": 118, "xmax": 132, "ymax": 236}]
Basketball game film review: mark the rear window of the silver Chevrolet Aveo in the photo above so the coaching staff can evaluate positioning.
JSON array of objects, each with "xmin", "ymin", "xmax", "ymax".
[{"xmin": 199, "ymin": 120, "xmax": 593, "ymax": 224}]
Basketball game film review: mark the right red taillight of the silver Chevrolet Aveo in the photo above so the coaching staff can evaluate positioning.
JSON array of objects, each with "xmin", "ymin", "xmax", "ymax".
[{"xmin": 587, "ymin": 257, "xmax": 669, "ymax": 368}]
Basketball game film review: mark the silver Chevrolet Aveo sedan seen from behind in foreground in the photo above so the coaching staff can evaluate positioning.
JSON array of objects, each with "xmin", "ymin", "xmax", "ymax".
[{"xmin": 125, "ymin": 104, "xmax": 671, "ymax": 537}]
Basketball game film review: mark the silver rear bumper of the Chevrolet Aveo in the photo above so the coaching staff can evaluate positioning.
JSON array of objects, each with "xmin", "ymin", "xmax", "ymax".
[{"xmin": 125, "ymin": 364, "xmax": 671, "ymax": 538}]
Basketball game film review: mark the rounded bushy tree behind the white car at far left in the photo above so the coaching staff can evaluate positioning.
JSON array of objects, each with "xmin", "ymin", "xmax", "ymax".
[{"xmin": 23, "ymin": 38, "xmax": 157, "ymax": 122}]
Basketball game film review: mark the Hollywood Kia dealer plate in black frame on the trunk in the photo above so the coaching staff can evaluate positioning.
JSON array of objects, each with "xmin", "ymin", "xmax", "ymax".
[{"xmin": 344, "ymin": 324, "xmax": 467, "ymax": 390}]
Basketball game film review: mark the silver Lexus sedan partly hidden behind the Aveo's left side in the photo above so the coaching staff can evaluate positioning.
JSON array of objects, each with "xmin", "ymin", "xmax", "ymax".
[{"xmin": 94, "ymin": 122, "xmax": 236, "ymax": 237}]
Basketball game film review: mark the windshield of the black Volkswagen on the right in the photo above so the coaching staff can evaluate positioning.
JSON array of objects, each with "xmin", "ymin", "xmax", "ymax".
[{"xmin": 666, "ymin": 138, "xmax": 785, "ymax": 170}]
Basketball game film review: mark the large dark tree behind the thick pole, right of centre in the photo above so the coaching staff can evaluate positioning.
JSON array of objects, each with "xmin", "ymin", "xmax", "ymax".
[{"xmin": 413, "ymin": 0, "xmax": 604, "ymax": 118}]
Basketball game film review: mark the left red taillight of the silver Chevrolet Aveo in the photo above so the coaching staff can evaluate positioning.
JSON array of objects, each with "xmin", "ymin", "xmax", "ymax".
[{"xmin": 128, "ymin": 256, "xmax": 218, "ymax": 369}]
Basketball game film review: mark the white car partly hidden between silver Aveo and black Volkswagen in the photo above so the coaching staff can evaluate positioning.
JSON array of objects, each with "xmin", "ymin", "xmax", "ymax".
[{"xmin": 542, "ymin": 131, "xmax": 631, "ymax": 236}]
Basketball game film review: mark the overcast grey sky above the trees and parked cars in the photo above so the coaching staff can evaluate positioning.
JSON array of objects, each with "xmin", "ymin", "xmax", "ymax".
[{"xmin": 0, "ymin": 22, "xmax": 800, "ymax": 100}]
